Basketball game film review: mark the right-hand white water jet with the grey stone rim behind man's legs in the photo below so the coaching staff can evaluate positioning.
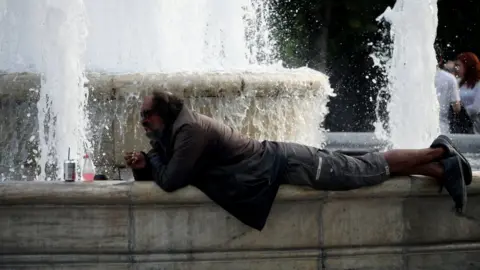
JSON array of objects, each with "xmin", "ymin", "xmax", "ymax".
[{"xmin": 338, "ymin": 0, "xmax": 480, "ymax": 170}]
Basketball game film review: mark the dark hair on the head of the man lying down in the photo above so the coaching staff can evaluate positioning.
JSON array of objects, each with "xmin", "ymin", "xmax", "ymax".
[{"xmin": 152, "ymin": 90, "xmax": 183, "ymax": 126}]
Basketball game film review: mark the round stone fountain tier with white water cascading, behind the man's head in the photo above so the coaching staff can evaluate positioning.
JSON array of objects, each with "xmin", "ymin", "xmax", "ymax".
[{"xmin": 0, "ymin": 0, "xmax": 331, "ymax": 180}]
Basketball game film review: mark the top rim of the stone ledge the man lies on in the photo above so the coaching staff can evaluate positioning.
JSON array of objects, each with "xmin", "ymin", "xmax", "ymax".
[{"xmin": 0, "ymin": 172, "xmax": 480, "ymax": 205}]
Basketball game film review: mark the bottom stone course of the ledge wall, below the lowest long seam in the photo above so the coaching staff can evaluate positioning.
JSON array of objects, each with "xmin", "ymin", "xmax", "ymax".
[{"xmin": 0, "ymin": 243, "xmax": 480, "ymax": 270}]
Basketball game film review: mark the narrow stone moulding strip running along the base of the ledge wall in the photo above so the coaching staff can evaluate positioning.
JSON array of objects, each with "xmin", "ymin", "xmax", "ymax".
[{"xmin": 0, "ymin": 242, "xmax": 480, "ymax": 263}]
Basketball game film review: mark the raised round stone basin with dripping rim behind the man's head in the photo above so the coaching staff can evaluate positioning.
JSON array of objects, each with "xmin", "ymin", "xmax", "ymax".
[{"xmin": 0, "ymin": 68, "xmax": 331, "ymax": 179}]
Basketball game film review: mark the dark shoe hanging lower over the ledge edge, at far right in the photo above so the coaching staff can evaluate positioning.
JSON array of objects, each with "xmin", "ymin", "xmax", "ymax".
[{"xmin": 440, "ymin": 156, "xmax": 467, "ymax": 213}]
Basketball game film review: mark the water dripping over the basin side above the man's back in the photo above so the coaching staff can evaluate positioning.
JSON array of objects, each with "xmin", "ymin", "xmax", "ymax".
[{"xmin": 187, "ymin": 68, "xmax": 333, "ymax": 148}]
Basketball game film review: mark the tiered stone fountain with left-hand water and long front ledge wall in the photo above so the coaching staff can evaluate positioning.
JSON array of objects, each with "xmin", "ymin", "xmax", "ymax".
[{"xmin": 0, "ymin": 0, "xmax": 480, "ymax": 270}]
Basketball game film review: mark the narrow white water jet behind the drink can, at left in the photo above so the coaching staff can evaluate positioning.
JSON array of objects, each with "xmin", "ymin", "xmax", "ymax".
[{"xmin": 37, "ymin": 0, "xmax": 89, "ymax": 180}]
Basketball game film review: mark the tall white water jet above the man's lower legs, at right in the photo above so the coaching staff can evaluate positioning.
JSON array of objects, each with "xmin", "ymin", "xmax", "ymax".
[{"xmin": 376, "ymin": 0, "xmax": 439, "ymax": 148}]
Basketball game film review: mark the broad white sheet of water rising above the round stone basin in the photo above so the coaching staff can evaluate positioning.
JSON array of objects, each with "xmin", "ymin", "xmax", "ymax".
[{"xmin": 79, "ymin": 0, "xmax": 278, "ymax": 73}]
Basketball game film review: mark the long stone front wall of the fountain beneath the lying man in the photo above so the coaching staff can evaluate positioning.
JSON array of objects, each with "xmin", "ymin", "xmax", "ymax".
[{"xmin": 0, "ymin": 173, "xmax": 480, "ymax": 270}]
